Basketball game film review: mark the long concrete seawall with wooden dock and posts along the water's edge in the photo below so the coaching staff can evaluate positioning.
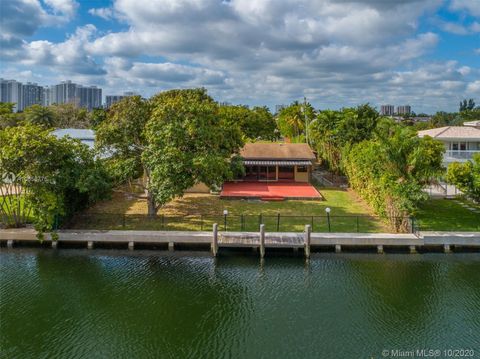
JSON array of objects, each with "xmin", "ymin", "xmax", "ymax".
[{"xmin": 0, "ymin": 224, "xmax": 480, "ymax": 258}]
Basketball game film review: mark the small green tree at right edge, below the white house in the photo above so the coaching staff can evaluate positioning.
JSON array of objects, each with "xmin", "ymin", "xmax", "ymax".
[{"xmin": 446, "ymin": 154, "xmax": 480, "ymax": 201}]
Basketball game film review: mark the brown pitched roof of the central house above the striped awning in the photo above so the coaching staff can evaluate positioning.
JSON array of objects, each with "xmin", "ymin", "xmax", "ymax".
[{"xmin": 240, "ymin": 143, "xmax": 315, "ymax": 161}]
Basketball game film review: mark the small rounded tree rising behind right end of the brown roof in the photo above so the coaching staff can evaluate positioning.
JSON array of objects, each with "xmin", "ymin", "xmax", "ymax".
[{"xmin": 277, "ymin": 101, "xmax": 315, "ymax": 142}]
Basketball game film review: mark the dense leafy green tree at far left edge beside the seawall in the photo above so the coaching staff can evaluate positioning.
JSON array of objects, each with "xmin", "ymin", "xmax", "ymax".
[{"xmin": 0, "ymin": 123, "xmax": 111, "ymax": 232}]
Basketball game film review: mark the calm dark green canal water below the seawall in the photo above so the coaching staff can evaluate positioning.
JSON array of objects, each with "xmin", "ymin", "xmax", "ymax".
[{"xmin": 0, "ymin": 249, "xmax": 480, "ymax": 358}]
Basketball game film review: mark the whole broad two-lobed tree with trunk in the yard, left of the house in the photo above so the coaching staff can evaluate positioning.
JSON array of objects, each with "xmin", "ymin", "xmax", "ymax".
[{"xmin": 97, "ymin": 89, "xmax": 242, "ymax": 216}]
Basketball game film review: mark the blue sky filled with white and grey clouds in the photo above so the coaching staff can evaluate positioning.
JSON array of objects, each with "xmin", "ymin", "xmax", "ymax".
[{"xmin": 0, "ymin": 0, "xmax": 480, "ymax": 113}]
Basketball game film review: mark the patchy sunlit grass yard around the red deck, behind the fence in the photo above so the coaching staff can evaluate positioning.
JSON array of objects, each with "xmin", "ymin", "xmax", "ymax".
[{"xmin": 72, "ymin": 188, "xmax": 388, "ymax": 232}]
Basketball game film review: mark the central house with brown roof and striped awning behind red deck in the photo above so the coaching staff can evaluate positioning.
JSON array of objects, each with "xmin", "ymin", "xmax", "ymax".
[{"xmin": 237, "ymin": 143, "xmax": 316, "ymax": 182}]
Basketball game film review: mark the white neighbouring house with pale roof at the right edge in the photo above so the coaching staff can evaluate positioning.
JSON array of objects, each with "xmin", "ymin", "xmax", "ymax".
[{"xmin": 418, "ymin": 126, "xmax": 480, "ymax": 164}]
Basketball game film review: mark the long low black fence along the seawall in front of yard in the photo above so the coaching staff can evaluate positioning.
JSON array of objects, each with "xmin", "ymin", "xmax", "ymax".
[{"xmin": 61, "ymin": 213, "xmax": 415, "ymax": 233}]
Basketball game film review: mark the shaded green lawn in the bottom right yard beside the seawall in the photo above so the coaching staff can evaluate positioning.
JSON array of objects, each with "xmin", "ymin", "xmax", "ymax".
[{"xmin": 415, "ymin": 199, "xmax": 480, "ymax": 231}]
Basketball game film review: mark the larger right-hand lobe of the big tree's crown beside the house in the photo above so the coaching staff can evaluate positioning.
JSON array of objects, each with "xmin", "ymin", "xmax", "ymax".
[{"xmin": 142, "ymin": 89, "xmax": 242, "ymax": 207}]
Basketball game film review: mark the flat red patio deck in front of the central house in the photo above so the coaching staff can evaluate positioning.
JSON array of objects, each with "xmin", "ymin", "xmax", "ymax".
[{"xmin": 220, "ymin": 182, "xmax": 323, "ymax": 201}]
